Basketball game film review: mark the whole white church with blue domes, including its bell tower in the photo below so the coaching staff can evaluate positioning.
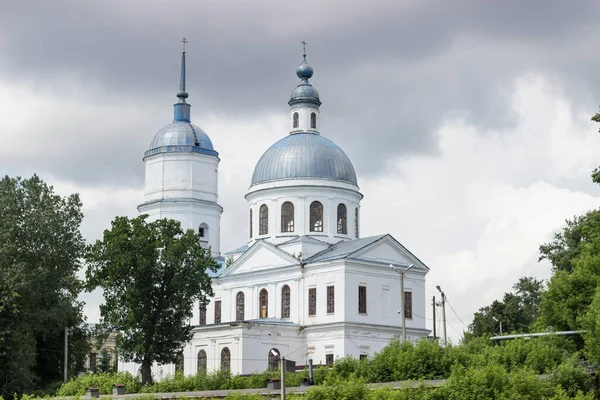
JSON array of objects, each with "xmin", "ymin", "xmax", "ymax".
[{"xmin": 120, "ymin": 42, "xmax": 429, "ymax": 379}]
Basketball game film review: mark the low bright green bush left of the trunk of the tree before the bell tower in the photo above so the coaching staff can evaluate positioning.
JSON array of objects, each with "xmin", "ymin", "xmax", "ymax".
[{"xmin": 56, "ymin": 372, "xmax": 142, "ymax": 396}]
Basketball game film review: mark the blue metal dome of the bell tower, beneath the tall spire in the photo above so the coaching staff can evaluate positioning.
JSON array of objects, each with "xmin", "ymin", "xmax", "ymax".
[{"xmin": 144, "ymin": 121, "xmax": 219, "ymax": 157}]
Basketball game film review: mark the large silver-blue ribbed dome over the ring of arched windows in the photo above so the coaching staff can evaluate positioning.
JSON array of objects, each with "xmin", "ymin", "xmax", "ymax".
[{"xmin": 250, "ymin": 132, "xmax": 358, "ymax": 186}]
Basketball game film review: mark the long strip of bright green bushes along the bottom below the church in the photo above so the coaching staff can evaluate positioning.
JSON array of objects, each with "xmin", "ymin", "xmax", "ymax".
[{"xmin": 52, "ymin": 336, "xmax": 591, "ymax": 400}]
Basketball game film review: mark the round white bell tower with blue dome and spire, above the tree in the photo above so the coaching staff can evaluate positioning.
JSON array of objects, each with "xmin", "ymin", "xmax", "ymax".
[{"xmin": 138, "ymin": 38, "xmax": 223, "ymax": 259}]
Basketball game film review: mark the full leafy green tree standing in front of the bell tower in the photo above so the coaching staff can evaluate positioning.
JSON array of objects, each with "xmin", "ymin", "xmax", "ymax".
[{"xmin": 86, "ymin": 215, "xmax": 219, "ymax": 384}]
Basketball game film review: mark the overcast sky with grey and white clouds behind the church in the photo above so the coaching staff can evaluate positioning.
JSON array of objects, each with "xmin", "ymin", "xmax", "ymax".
[{"xmin": 0, "ymin": 0, "xmax": 600, "ymax": 340}]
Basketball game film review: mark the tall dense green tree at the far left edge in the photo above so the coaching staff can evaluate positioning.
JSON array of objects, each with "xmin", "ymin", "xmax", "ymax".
[{"xmin": 0, "ymin": 175, "xmax": 85, "ymax": 397}]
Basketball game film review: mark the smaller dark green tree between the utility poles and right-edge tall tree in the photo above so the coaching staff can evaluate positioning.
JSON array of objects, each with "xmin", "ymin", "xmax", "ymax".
[{"xmin": 465, "ymin": 277, "xmax": 544, "ymax": 341}]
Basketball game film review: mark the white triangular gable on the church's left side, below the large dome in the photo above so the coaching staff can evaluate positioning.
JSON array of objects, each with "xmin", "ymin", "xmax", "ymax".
[{"xmin": 221, "ymin": 242, "xmax": 298, "ymax": 277}]
